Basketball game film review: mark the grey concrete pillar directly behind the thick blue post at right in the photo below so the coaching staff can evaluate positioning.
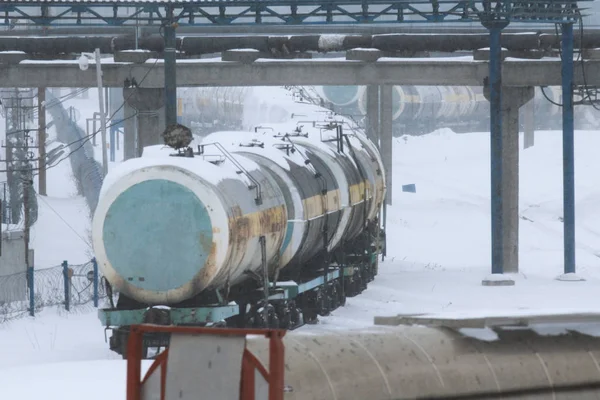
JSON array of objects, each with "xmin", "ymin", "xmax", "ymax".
[{"xmin": 501, "ymin": 87, "xmax": 534, "ymax": 273}]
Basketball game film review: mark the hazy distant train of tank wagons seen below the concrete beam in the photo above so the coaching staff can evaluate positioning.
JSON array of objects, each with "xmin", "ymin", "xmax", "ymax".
[{"xmin": 180, "ymin": 85, "xmax": 596, "ymax": 136}]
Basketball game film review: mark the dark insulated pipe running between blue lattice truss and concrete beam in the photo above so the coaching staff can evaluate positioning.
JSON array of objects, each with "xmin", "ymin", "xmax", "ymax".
[{"xmin": 0, "ymin": 31, "xmax": 600, "ymax": 56}]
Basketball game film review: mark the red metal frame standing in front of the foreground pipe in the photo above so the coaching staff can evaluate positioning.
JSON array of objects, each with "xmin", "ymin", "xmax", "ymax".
[{"xmin": 127, "ymin": 324, "xmax": 286, "ymax": 400}]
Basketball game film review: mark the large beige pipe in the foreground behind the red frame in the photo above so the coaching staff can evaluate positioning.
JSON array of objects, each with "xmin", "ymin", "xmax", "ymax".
[{"xmin": 248, "ymin": 326, "xmax": 600, "ymax": 400}]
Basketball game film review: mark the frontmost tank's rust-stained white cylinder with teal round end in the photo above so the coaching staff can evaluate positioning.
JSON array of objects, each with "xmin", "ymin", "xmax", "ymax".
[{"xmin": 92, "ymin": 141, "xmax": 287, "ymax": 305}]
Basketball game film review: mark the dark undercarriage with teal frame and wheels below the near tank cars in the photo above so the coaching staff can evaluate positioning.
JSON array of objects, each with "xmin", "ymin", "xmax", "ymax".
[{"xmin": 99, "ymin": 219, "xmax": 386, "ymax": 358}]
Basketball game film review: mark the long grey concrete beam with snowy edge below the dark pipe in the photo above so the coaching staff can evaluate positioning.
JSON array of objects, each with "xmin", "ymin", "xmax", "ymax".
[{"xmin": 0, "ymin": 57, "xmax": 600, "ymax": 88}]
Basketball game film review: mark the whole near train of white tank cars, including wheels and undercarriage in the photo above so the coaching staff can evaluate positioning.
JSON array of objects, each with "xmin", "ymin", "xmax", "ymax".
[{"xmin": 92, "ymin": 99, "xmax": 385, "ymax": 355}]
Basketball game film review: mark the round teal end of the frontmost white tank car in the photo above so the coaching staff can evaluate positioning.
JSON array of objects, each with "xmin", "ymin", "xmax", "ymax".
[{"xmin": 103, "ymin": 179, "xmax": 213, "ymax": 292}]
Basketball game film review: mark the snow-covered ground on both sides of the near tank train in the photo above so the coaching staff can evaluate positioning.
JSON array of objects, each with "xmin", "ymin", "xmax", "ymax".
[{"xmin": 0, "ymin": 86, "xmax": 600, "ymax": 400}]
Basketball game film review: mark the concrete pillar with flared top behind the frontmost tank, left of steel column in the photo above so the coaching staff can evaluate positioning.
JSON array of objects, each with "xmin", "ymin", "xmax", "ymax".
[{"xmin": 123, "ymin": 88, "xmax": 165, "ymax": 156}]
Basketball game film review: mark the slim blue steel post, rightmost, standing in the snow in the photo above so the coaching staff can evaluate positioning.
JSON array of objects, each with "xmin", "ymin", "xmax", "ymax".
[{"xmin": 562, "ymin": 23, "xmax": 575, "ymax": 274}]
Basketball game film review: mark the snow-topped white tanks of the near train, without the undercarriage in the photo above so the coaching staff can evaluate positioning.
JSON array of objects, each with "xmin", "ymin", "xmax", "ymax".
[{"xmin": 93, "ymin": 96, "xmax": 385, "ymax": 305}]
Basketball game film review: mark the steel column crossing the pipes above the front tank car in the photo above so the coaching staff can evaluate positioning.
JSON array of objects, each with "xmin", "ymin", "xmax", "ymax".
[{"xmin": 164, "ymin": 12, "xmax": 177, "ymax": 126}]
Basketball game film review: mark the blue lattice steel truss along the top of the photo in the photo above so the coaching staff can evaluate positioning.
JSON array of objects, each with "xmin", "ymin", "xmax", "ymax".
[{"xmin": 0, "ymin": 0, "xmax": 586, "ymax": 28}]
